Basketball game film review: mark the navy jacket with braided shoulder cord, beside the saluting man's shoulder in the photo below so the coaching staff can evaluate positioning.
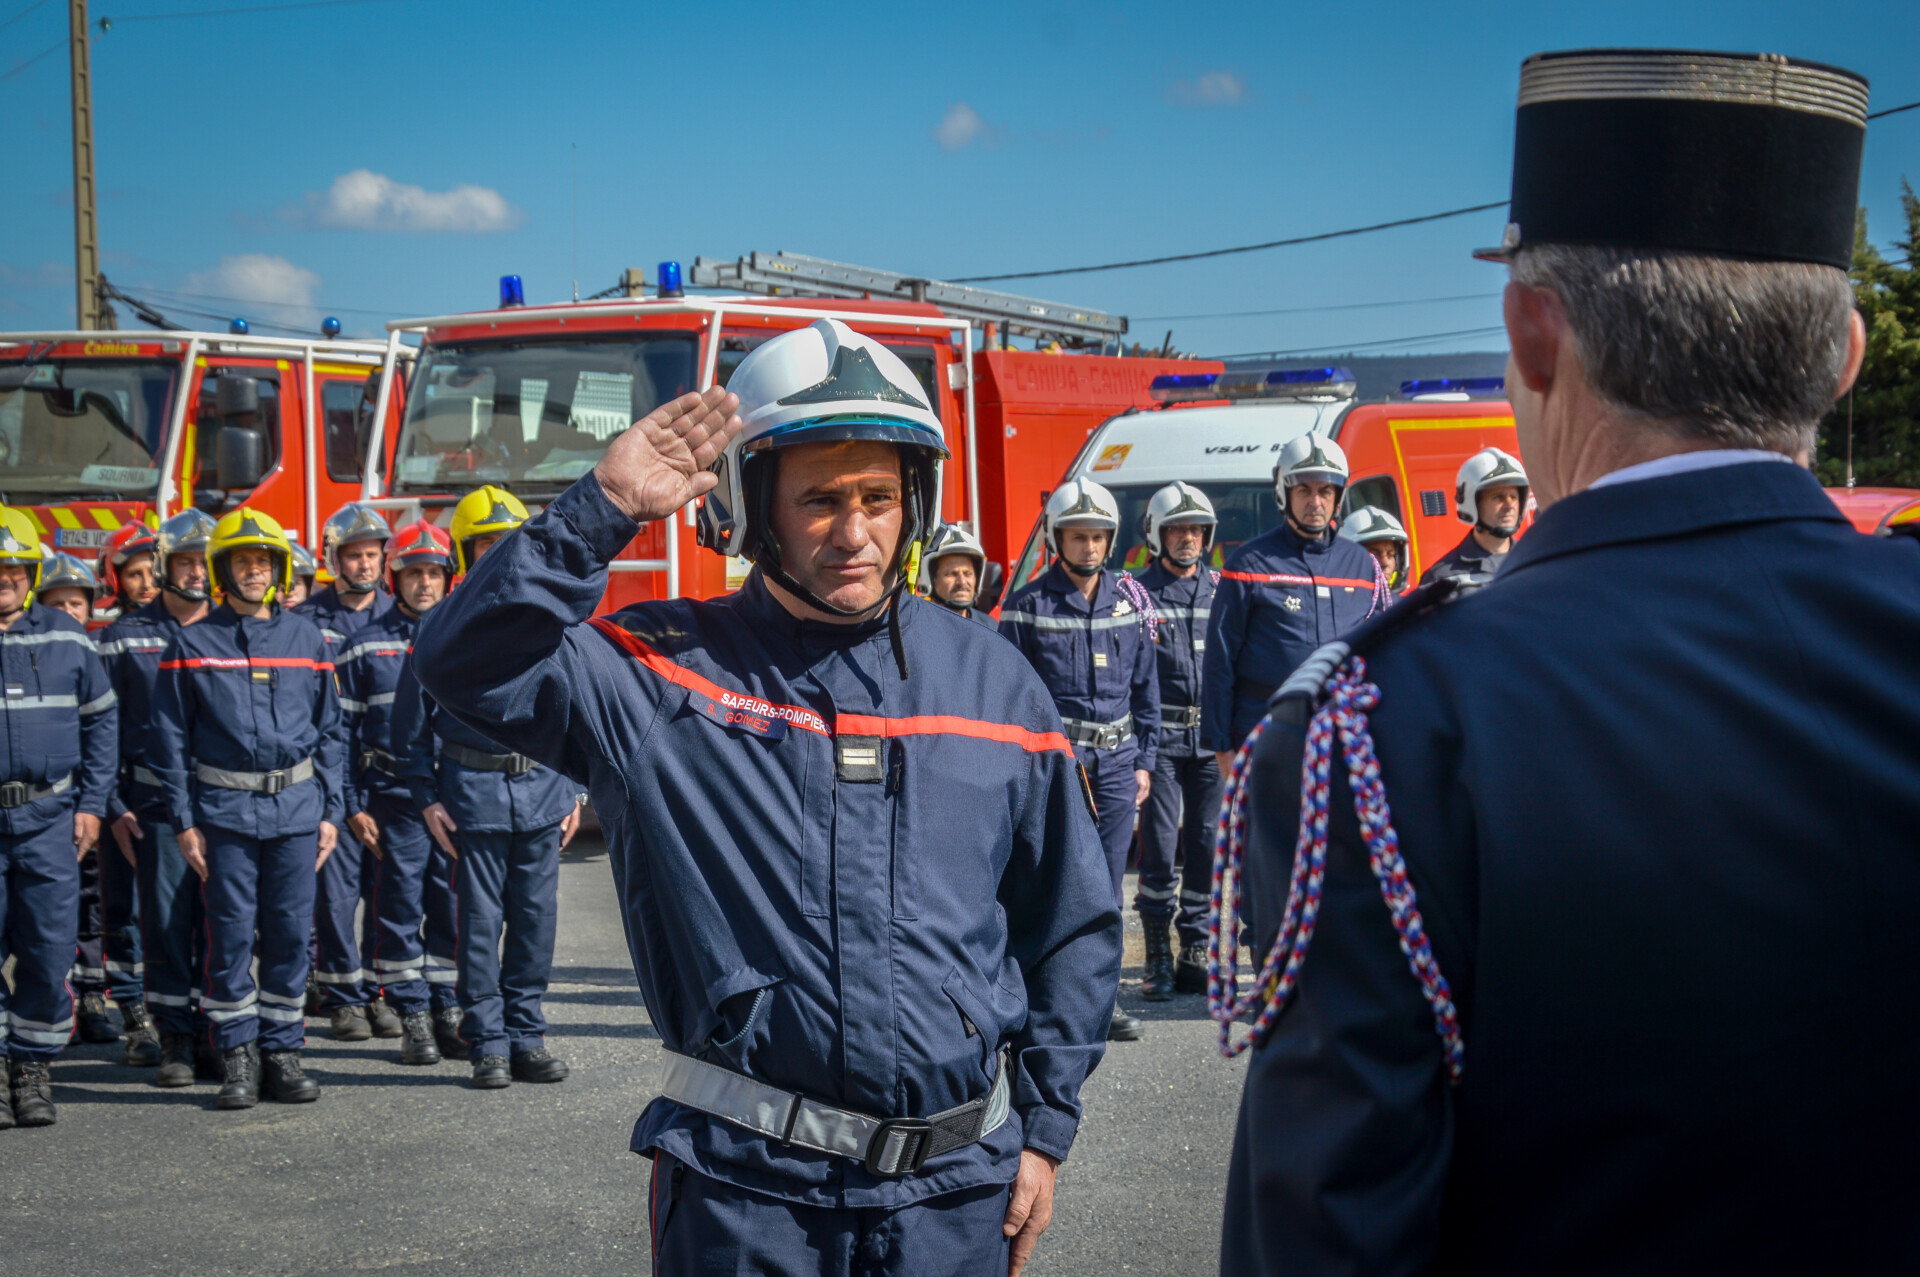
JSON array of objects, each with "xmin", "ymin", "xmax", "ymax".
[{"xmin": 1000, "ymin": 563, "xmax": 1160, "ymax": 772}]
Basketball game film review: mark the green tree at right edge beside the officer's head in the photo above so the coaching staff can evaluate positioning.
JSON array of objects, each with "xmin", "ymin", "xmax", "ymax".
[{"xmin": 1814, "ymin": 182, "xmax": 1920, "ymax": 488}]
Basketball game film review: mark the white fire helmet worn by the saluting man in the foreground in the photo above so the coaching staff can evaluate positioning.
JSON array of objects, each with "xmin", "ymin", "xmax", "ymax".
[{"xmin": 697, "ymin": 319, "xmax": 947, "ymax": 613}]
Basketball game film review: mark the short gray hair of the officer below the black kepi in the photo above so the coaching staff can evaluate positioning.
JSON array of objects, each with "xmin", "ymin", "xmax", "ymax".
[{"xmin": 1513, "ymin": 244, "xmax": 1853, "ymax": 453}]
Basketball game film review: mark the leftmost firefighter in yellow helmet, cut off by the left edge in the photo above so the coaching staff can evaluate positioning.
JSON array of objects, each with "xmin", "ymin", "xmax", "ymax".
[{"xmin": 0, "ymin": 507, "xmax": 119, "ymax": 1127}]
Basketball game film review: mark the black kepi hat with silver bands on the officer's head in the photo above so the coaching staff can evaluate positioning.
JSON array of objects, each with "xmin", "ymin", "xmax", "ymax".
[{"xmin": 1475, "ymin": 48, "xmax": 1866, "ymax": 271}]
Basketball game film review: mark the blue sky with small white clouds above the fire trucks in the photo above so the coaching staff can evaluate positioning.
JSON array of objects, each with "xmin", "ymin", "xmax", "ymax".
[{"xmin": 0, "ymin": 0, "xmax": 1920, "ymax": 353}]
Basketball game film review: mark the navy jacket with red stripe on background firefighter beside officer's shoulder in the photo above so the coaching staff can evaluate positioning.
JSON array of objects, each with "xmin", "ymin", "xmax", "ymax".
[{"xmin": 1200, "ymin": 522, "xmax": 1379, "ymax": 753}]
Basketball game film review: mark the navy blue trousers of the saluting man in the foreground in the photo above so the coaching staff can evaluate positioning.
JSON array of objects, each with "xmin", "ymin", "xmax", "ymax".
[{"xmin": 647, "ymin": 1152, "xmax": 1012, "ymax": 1277}]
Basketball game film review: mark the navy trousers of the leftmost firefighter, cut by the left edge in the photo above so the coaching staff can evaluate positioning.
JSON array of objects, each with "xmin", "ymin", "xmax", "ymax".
[{"xmin": 0, "ymin": 807, "xmax": 81, "ymax": 1060}]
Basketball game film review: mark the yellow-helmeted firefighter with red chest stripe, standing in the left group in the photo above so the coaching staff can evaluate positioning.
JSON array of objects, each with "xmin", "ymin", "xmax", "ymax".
[{"xmin": 152, "ymin": 507, "xmax": 344, "ymax": 1108}]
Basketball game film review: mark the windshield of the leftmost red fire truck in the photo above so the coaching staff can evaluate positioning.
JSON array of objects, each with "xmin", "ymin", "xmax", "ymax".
[{"xmin": 0, "ymin": 359, "xmax": 180, "ymax": 505}]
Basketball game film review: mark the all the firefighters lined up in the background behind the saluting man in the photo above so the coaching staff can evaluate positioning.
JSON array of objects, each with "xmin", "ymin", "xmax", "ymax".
[{"xmin": 0, "ymin": 436, "xmax": 1526, "ymax": 1125}]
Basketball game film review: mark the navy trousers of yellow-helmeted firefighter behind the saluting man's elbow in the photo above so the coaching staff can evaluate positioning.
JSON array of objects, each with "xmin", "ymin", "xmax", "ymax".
[{"xmin": 453, "ymin": 824, "xmax": 561, "ymax": 1060}]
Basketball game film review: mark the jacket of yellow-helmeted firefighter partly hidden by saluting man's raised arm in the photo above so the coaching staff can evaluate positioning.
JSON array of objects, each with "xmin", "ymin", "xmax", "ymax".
[{"xmin": 388, "ymin": 626, "xmax": 580, "ymax": 833}]
